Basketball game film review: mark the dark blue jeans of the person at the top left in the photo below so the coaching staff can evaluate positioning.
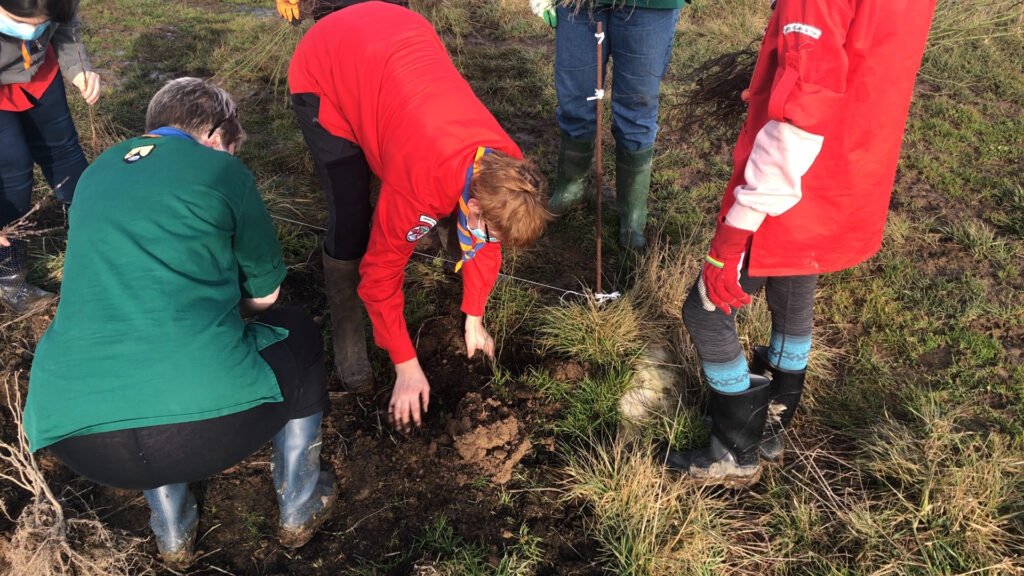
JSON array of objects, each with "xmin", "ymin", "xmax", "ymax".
[{"xmin": 0, "ymin": 74, "xmax": 89, "ymax": 227}]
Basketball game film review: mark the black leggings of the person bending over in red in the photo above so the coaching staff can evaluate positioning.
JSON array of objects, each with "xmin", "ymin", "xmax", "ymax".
[{"xmin": 292, "ymin": 94, "xmax": 373, "ymax": 260}]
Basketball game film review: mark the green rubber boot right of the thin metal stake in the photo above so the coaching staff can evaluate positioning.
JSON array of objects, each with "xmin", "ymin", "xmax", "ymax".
[{"xmin": 615, "ymin": 147, "xmax": 654, "ymax": 250}]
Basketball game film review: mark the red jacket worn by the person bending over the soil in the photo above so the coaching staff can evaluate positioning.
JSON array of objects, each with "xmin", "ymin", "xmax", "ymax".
[{"xmin": 288, "ymin": 2, "xmax": 522, "ymax": 364}]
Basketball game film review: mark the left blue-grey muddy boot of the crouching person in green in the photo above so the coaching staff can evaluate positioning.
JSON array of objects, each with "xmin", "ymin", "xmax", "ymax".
[{"xmin": 142, "ymin": 484, "xmax": 199, "ymax": 570}]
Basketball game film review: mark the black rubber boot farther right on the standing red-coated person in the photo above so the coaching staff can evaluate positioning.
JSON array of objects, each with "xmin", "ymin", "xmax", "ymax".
[{"xmin": 751, "ymin": 346, "xmax": 807, "ymax": 460}]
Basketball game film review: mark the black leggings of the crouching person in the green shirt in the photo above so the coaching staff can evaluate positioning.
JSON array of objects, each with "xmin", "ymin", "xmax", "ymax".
[{"xmin": 49, "ymin": 307, "xmax": 330, "ymax": 490}]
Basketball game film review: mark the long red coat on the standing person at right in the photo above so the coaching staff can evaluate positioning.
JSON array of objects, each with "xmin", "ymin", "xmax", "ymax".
[{"xmin": 720, "ymin": 0, "xmax": 936, "ymax": 276}]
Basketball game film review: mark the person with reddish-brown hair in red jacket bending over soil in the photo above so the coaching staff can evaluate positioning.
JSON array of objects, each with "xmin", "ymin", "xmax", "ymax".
[{"xmin": 288, "ymin": 2, "xmax": 551, "ymax": 428}]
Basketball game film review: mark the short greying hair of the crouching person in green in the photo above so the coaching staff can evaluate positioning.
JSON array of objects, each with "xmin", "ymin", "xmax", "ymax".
[{"xmin": 145, "ymin": 77, "xmax": 246, "ymax": 148}]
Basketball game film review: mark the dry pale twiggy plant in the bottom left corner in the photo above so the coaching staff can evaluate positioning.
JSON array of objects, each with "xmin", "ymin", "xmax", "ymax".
[{"xmin": 0, "ymin": 373, "xmax": 156, "ymax": 576}]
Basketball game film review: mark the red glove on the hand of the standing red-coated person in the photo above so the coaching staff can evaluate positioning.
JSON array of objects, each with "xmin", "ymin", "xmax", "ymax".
[{"xmin": 697, "ymin": 218, "xmax": 754, "ymax": 314}]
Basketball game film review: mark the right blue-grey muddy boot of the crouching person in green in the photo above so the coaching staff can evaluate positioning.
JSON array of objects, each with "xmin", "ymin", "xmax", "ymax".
[{"xmin": 270, "ymin": 412, "xmax": 338, "ymax": 548}]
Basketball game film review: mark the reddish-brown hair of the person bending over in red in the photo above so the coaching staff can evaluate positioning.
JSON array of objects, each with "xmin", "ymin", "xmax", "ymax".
[{"xmin": 471, "ymin": 152, "xmax": 554, "ymax": 248}]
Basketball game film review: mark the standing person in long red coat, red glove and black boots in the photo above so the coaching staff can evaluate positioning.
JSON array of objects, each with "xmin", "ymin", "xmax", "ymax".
[{"xmin": 667, "ymin": 0, "xmax": 936, "ymax": 486}]
